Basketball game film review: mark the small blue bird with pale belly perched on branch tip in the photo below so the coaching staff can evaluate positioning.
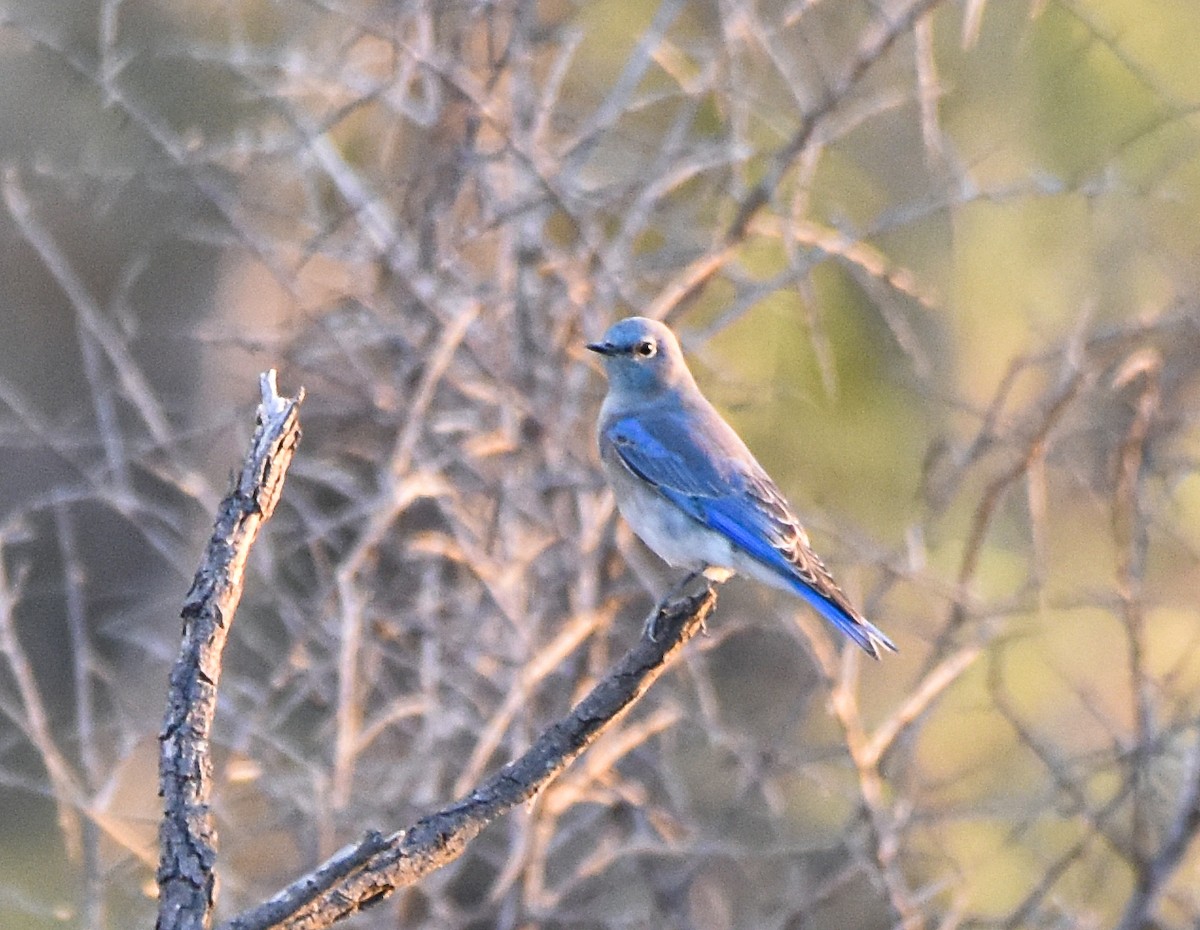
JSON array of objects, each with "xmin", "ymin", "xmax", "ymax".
[{"xmin": 587, "ymin": 317, "xmax": 896, "ymax": 659}]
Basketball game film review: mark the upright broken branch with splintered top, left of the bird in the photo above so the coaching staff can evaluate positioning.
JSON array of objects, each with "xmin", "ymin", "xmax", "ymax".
[{"xmin": 156, "ymin": 371, "xmax": 304, "ymax": 930}]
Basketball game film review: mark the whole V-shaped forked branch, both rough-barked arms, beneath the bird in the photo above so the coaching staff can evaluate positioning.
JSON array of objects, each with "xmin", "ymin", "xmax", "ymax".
[{"xmin": 158, "ymin": 372, "xmax": 716, "ymax": 930}]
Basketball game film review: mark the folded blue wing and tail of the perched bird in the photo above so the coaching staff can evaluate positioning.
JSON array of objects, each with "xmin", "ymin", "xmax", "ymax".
[{"xmin": 604, "ymin": 412, "xmax": 895, "ymax": 656}]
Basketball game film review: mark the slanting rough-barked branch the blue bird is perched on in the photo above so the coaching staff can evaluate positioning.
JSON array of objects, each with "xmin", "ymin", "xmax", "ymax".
[{"xmin": 221, "ymin": 576, "xmax": 716, "ymax": 930}]
